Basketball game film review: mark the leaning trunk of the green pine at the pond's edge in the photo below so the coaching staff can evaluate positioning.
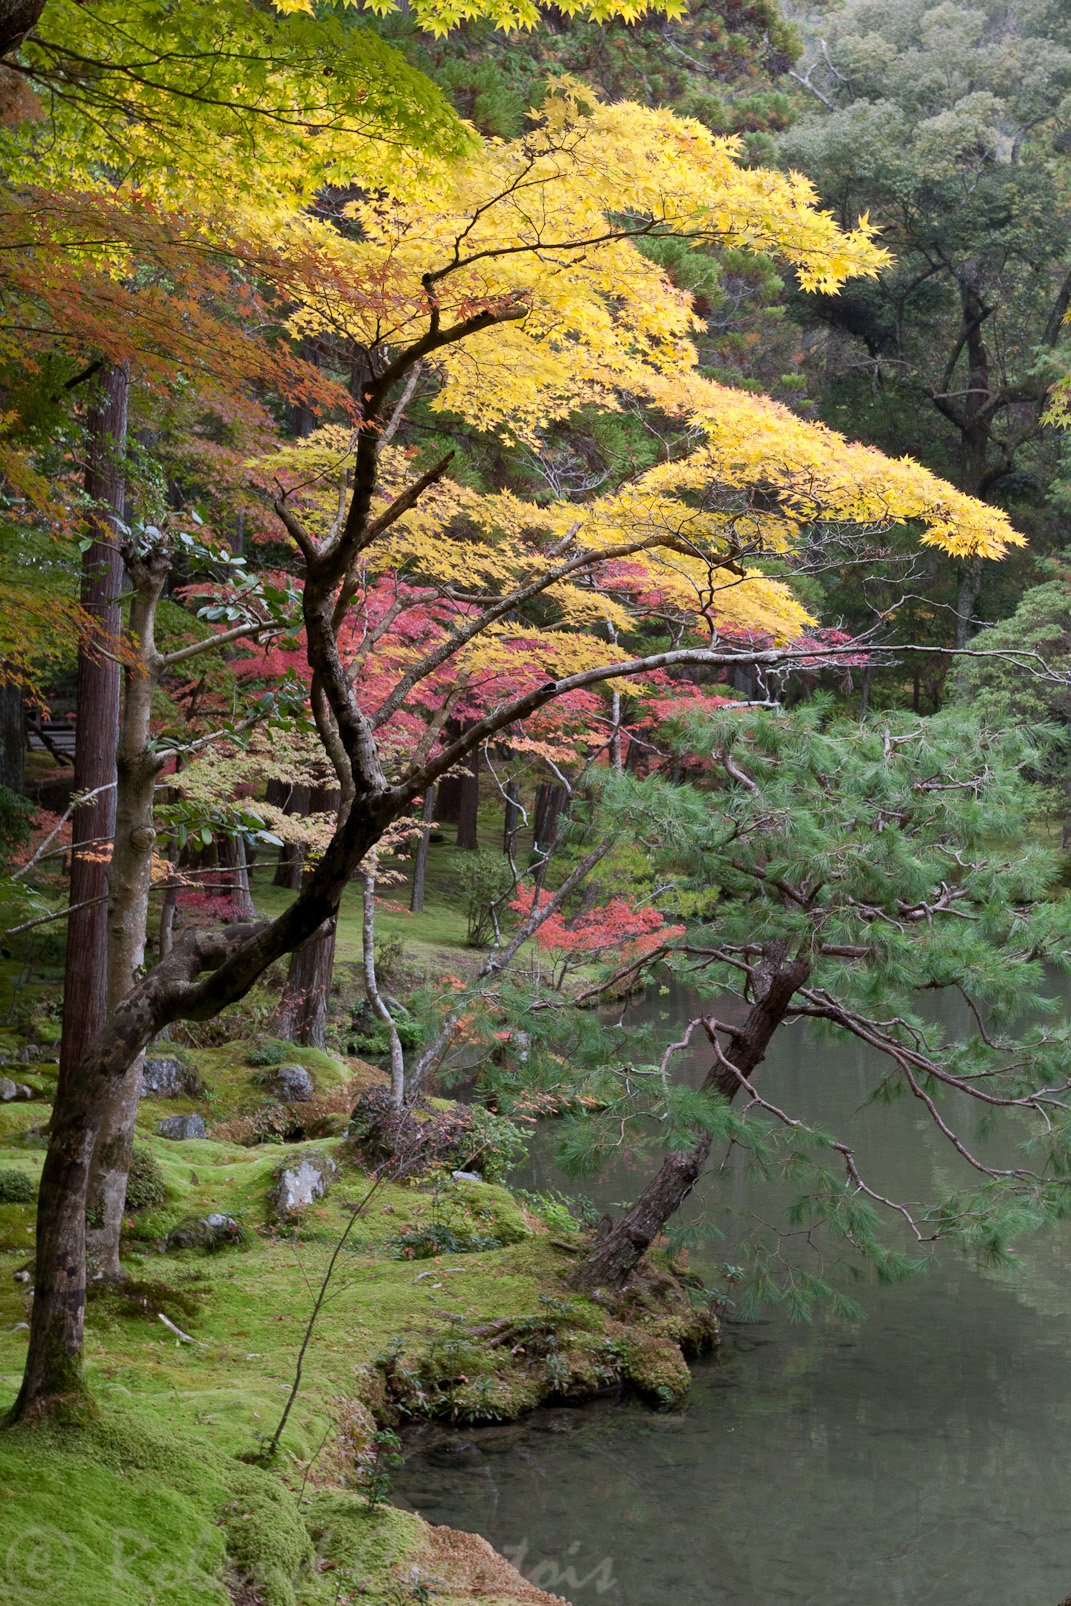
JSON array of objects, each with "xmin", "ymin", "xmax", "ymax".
[{"xmin": 570, "ymin": 944, "xmax": 811, "ymax": 1290}]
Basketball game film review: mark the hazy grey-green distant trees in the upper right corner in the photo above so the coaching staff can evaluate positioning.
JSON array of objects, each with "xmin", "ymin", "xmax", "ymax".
[{"xmin": 780, "ymin": 0, "xmax": 1071, "ymax": 658}]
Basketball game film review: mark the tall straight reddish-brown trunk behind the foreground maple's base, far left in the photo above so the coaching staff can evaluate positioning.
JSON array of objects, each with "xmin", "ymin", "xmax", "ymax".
[{"xmin": 58, "ymin": 366, "xmax": 130, "ymax": 1117}]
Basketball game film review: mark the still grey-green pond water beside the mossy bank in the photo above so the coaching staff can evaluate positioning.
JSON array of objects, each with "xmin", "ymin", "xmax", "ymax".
[{"xmin": 397, "ymin": 996, "xmax": 1071, "ymax": 1606}]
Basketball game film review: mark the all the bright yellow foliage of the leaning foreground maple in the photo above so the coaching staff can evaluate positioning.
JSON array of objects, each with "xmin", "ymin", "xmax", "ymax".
[{"xmin": 256, "ymin": 82, "xmax": 1023, "ymax": 675}]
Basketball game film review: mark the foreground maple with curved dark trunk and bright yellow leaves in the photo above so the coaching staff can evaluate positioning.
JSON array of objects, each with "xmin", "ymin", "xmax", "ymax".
[{"xmin": 2, "ymin": 87, "xmax": 1018, "ymax": 1416}]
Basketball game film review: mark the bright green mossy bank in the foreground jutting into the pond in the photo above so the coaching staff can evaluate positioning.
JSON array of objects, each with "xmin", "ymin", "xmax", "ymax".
[{"xmin": 0, "ymin": 1111, "xmax": 711, "ymax": 1606}]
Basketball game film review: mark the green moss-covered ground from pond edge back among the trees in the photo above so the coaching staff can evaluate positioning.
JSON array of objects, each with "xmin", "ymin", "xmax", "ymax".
[{"xmin": 0, "ymin": 796, "xmax": 711, "ymax": 1606}]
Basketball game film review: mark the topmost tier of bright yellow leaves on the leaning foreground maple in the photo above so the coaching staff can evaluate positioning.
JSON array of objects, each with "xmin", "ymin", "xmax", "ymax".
[{"xmin": 294, "ymin": 84, "xmax": 888, "ymax": 440}]
